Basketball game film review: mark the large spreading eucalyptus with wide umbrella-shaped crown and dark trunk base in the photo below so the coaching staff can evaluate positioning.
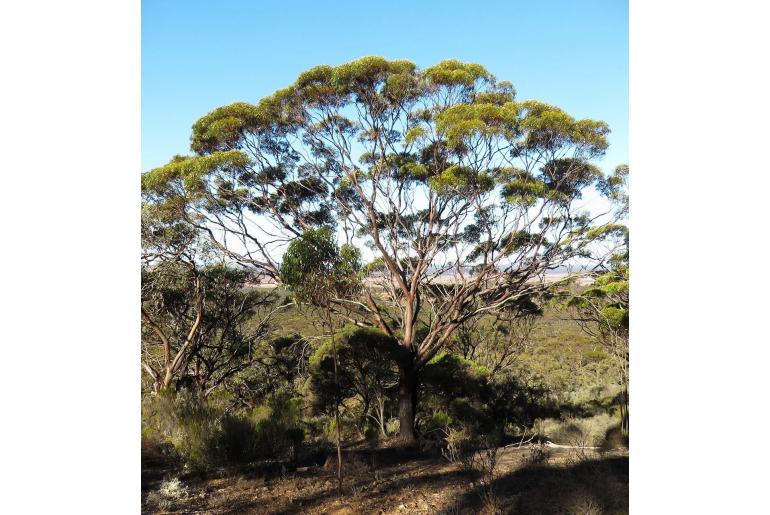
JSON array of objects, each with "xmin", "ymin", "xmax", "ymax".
[{"xmin": 142, "ymin": 57, "xmax": 609, "ymax": 441}]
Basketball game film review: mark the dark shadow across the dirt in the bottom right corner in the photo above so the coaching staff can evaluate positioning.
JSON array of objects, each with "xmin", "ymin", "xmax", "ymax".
[{"xmin": 445, "ymin": 456, "xmax": 628, "ymax": 515}]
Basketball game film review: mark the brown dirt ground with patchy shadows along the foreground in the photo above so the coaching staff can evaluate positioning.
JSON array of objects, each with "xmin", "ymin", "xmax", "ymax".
[{"xmin": 142, "ymin": 447, "xmax": 628, "ymax": 515}]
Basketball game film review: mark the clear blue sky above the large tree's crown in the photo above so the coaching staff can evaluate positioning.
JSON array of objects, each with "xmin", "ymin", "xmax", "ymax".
[{"xmin": 142, "ymin": 0, "xmax": 628, "ymax": 171}]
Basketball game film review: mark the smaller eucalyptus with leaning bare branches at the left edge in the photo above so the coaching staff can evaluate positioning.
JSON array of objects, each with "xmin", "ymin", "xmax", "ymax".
[{"xmin": 141, "ymin": 205, "xmax": 282, "ymax": 396}]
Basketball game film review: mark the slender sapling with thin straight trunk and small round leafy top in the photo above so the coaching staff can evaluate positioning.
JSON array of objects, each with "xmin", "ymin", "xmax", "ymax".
[{"xmin": 280, "ymin": 227, "xmax": 361, "ymax": 491}]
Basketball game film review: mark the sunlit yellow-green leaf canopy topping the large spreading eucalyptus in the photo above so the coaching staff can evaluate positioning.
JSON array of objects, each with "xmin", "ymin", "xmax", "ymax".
[{"xmin": 142, "ymin": 56, "xmax": 612, "ymax": 236}]
